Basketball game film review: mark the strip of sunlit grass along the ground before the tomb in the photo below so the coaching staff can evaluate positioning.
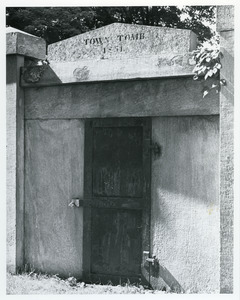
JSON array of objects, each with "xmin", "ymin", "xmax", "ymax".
[{"xmin": 7, "ymin": 272, "xmax": 165, "ymax": 295}]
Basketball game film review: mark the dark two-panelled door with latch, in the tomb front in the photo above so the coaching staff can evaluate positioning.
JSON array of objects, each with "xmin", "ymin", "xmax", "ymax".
[{"xmin": 83, "ymin": 118, "xmax": 151, "ymax": 284}]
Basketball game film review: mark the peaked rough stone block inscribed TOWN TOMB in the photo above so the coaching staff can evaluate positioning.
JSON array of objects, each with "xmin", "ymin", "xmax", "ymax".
[{"xmin": 48, "ymin": 23, "xmax": 197, "ymax": 61}]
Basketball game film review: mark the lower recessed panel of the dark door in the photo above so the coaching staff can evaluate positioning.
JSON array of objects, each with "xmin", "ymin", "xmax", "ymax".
[{"xmin": 91, "ymin": 208, "xmax": 142, "ymax": 276}]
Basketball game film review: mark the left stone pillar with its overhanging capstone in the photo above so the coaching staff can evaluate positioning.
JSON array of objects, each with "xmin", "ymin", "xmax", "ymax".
[{"xmin": 6, "ymin": 27, "xmax": 46, "ymax": 273}]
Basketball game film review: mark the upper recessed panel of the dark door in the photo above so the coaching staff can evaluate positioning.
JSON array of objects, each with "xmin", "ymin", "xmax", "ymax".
[{"xmin": 93, "ymin": 126, "xmax": 143, "ymax": 197}]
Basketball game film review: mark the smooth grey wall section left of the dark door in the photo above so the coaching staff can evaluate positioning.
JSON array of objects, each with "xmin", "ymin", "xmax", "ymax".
[{"xmin": 25, "ymin": 120, "xmax": 84, "ymax": 278}]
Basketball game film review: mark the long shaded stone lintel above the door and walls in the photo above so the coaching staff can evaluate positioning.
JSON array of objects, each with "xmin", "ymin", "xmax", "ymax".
[{"xmin": 25, "ymin": 77, "xmax": 219, "ymax": 119}]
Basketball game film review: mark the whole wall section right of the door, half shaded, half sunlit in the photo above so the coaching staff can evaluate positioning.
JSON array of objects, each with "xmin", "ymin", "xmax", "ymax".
[{"xmin": 151, "ymin": 116, "xmax": 220, "ymax": 293}]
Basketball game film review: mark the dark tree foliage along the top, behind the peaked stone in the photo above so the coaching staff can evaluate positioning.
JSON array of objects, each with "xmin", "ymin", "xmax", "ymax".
[{"xmin": 6, "ymin": 6, "xmax": 215, "ymax": 44}]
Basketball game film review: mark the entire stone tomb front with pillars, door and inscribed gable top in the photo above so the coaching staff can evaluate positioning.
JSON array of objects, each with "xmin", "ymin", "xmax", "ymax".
[{"xmin": 7, "ymin": 6, "xmax": 233, "ymax": 293}]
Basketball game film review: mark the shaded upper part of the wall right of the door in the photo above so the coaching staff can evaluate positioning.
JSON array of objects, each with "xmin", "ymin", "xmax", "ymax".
[{"xmin": 152, "ymin": 115, "xmax": 219, "ymax": 205}]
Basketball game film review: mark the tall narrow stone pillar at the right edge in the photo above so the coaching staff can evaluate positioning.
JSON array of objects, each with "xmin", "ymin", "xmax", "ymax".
[{"xmin": 217, "ymin": 5, "xmax": 234, "ymax": 293}]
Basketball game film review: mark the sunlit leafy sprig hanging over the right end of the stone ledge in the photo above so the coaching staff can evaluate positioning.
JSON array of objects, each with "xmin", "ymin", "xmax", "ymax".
[{"xmin": 193, "ymin": 35, "xmax": 226, "ymax": 97}]
